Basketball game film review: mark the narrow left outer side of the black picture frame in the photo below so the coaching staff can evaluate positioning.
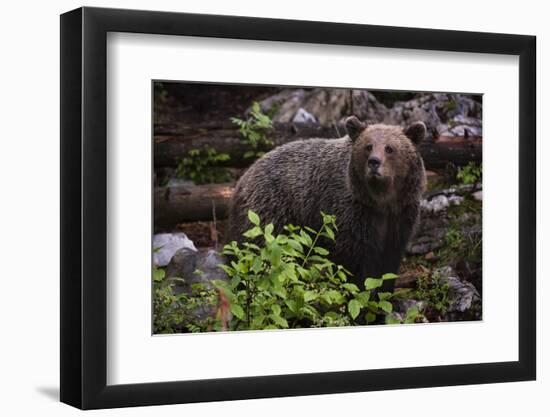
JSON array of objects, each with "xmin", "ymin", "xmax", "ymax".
[{"xmin": 60, "ymin": 9, "xmax": 82, "ymax": 407}]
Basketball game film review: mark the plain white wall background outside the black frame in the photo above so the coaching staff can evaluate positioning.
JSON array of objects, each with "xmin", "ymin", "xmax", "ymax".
[{"xmin": 0, "ymin": 0, "xmax": 550, "ymax": 416}]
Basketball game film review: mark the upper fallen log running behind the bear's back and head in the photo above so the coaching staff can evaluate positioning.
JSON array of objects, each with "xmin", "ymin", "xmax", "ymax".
[{"xmin": 154, "ymin": 123, "xmax": 482, "ymax": 169}]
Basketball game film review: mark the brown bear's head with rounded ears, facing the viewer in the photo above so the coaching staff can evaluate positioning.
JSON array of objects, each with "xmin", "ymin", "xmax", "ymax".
[{"xmin": 346, "ymin": 116, "xmax": 426, "ymax": 207}]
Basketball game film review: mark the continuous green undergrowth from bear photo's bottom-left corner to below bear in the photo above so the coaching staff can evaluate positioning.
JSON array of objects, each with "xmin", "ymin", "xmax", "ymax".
[{"xmin": 153, "ymin": 211, "xmax": 414, "ymax": 334}]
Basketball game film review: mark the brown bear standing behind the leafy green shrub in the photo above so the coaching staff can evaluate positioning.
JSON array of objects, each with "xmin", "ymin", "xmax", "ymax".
[{"xmin": 228, "ymin": 116, "xmax": 426, "ymax": 289}]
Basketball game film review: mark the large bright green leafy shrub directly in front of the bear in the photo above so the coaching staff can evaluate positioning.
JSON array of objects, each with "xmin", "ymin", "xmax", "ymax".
[{"xmin": 216, "ymin": 211, "xmax": 397, "ymax": 330}]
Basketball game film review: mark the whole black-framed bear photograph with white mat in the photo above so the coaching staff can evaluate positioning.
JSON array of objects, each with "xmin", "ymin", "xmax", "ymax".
[{"xmin": 60, "ymin": 7, "xmax": 536, "ymax": 409}]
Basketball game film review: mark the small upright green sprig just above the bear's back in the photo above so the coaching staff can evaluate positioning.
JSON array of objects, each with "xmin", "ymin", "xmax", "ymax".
[{"xmin": 230, "ymin": 101, "xmax": 273, "ymax": 159}]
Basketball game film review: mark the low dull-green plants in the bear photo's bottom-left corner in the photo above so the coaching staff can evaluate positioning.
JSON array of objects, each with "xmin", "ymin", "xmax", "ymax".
[{"xmin": 153, "ymin": 266, "xmax": 219, "ymax": 334}]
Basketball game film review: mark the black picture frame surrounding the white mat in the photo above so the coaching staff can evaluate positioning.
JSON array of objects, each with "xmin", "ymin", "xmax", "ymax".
[{"xmin": 60, "ymin": 7, "xmax": 536, "ymax": 409}]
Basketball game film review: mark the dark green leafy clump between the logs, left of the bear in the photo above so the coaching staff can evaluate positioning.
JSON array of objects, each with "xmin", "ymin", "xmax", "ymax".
[{"xmin": 176, "ymin": 147, "xmax": 232, "ymax": 184}]
